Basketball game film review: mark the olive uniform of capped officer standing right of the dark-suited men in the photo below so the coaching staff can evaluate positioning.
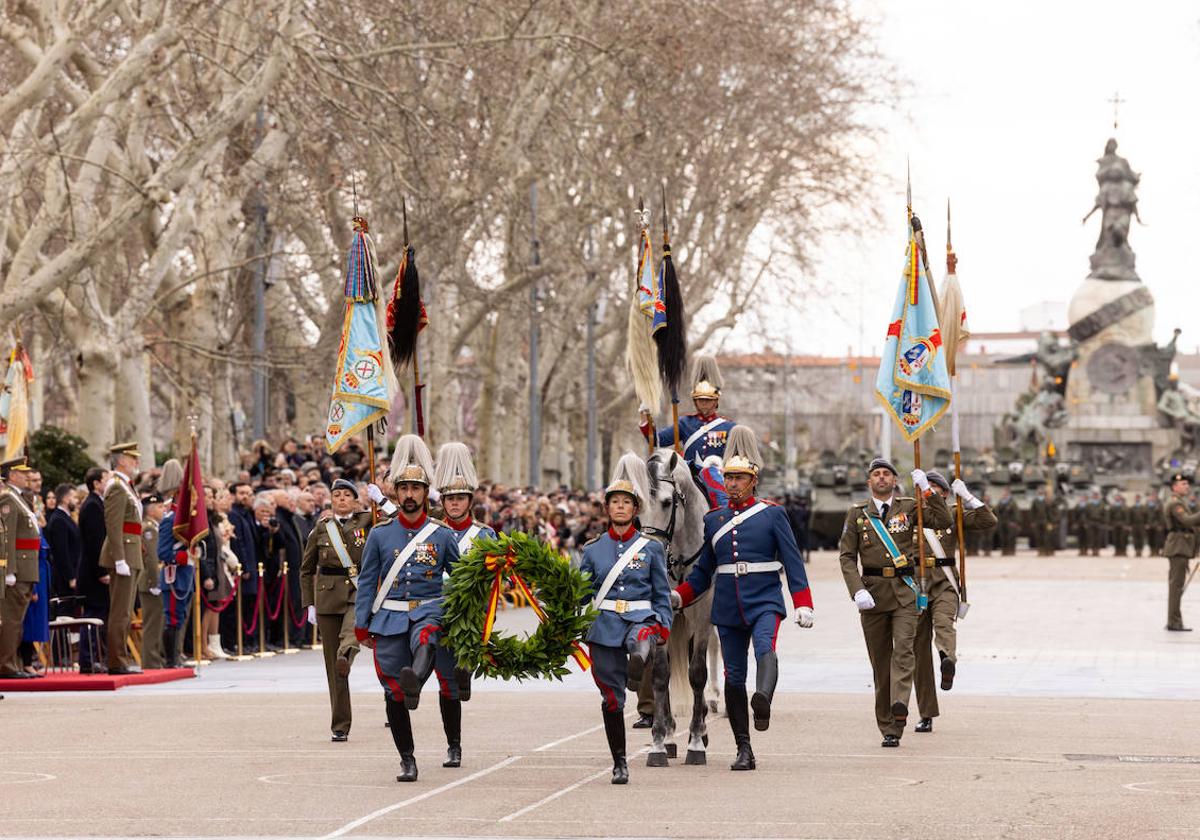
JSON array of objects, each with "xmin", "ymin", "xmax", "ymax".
[{"xmin": 100, "ymin": 470, "xmax": 143, "ymax": 671}]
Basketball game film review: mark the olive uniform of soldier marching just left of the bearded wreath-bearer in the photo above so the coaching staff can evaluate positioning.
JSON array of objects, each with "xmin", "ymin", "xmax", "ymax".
[{"xmin": 300, "ymin": 511, "xmax": 372, "ymax": 733}]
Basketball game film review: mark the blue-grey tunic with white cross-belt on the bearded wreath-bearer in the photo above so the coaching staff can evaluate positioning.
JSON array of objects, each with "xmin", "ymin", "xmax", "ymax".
[{"xmin": 354, "ymin": 512, "xmax": 458, "ymax": 636}]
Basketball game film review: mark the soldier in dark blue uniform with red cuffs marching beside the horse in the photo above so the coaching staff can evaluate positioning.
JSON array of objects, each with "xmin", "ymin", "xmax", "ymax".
[{"xmin": 671, "ymin": 426, "xmax": 812, "ymax": 770}]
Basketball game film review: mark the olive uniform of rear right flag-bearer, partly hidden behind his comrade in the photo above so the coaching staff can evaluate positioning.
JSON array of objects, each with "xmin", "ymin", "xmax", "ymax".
[{"xmin": 916, "ymin": 505, "xmax": 996, "ymax": 718}]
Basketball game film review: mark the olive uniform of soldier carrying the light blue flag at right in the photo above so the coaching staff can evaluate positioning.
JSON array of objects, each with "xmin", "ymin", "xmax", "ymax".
[{"xmin": 838, "ymin": 493, "xmax": 952, "ymax": 738}]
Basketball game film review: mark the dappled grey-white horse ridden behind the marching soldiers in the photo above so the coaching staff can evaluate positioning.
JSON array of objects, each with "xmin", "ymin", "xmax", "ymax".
[{"xmin": 641, "ymin": 449, "xmax": 716, "ymax": 767}]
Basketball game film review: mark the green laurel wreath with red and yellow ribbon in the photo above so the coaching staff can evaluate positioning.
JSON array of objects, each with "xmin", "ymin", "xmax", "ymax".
[{"xmin": 443, "ymin": 533, "xmax": 596, "ymax": 680}]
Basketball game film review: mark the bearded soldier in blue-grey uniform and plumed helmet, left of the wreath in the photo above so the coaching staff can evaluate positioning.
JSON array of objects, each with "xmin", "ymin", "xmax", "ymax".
[{"xmin": 354, "ymin": 434, "xmax": 458, "ymax": 781}]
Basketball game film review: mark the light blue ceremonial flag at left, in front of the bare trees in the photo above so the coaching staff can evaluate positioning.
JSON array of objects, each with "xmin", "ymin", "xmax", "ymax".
[{"xmin": 325, "ymin": 220, "xmax": 391, "ymax": 452}]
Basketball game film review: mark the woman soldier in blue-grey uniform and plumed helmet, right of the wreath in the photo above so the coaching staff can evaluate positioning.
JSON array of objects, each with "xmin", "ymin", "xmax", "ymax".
[{"xmin": 580, "ymin": 452, "xmax": 672, "ymax": 785}]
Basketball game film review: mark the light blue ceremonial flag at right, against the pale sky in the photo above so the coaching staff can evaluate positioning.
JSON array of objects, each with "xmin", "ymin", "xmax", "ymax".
[{"xmin": 875, "ymin": 220, "xmax": 950, "ymax": 443}]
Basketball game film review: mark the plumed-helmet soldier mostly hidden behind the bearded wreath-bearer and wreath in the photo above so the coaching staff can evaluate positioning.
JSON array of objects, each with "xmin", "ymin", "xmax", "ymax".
[{"xmin": 433, "ymin": 442, "xmax": 496, "ymax": 767}]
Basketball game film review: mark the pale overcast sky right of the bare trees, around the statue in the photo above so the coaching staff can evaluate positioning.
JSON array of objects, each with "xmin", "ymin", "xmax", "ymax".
[{"xmin": 720, "ymin": 0, "xmax": 1200, "ymax": 355}]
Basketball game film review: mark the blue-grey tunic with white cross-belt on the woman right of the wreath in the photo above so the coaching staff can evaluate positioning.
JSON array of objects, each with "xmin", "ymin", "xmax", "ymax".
[{"xmin": 580, "ymin": 528, "xmax": 672, "ymax": 648}]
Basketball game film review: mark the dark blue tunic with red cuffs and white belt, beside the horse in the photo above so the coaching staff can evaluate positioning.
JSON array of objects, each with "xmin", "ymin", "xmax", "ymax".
[{"xmin": 679, "ymin": 498, "xmax": 812, "ymax": 626}]
